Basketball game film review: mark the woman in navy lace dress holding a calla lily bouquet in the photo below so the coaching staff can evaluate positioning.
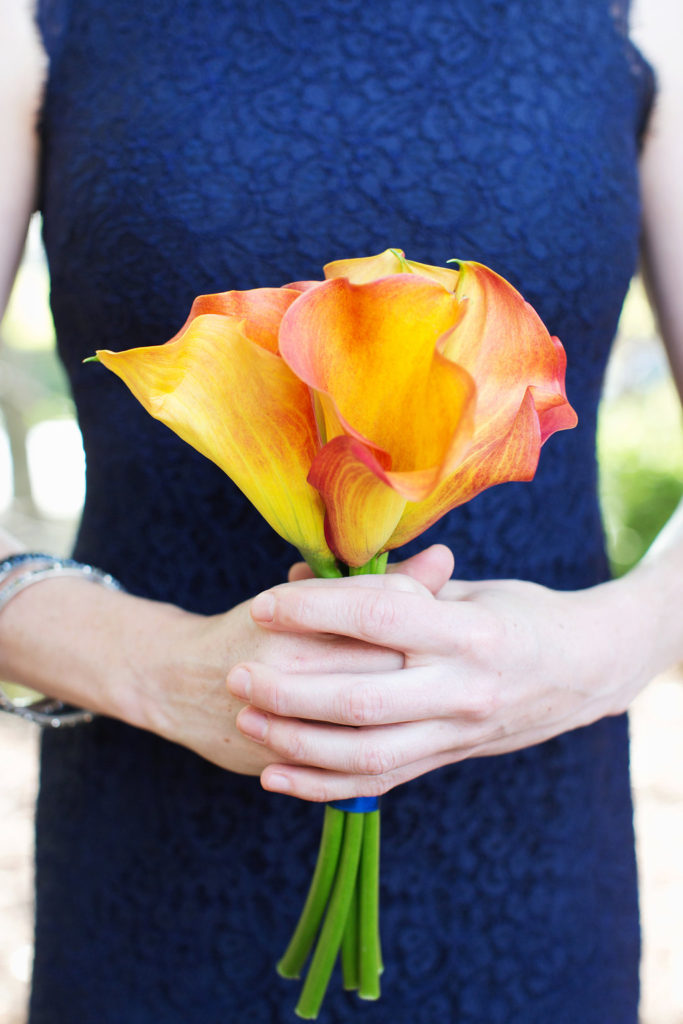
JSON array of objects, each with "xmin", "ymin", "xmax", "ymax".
[{"xmin": 0, "ymin": 0, "xmax": 683, "ymax": 1024}]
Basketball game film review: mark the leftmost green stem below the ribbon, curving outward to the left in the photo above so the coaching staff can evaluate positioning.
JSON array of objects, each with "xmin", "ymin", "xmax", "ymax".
[{"xmin": 278, "ymin": 806, "xmax": 345, "ymax": 978}]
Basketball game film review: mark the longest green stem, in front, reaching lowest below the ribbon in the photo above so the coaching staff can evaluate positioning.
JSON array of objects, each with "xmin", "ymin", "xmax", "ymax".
[{"xmin": 296, "ymin": 812, "xmax": 366, "ymax": 1020}]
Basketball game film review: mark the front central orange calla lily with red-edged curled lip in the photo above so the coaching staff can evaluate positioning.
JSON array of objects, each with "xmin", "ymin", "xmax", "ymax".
[{"xmin": 280, "ymin": 274, "xmax": 475, "ymax": 566}]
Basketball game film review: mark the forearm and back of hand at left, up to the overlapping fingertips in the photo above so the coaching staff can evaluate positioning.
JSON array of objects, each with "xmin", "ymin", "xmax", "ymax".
[{"xmin": 0, "ymin": 557, "xmax": 278, "ymax": 774}]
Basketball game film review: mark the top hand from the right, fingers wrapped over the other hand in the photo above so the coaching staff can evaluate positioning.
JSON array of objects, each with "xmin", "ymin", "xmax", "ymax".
[{"xmin": 228, "ymin": 577, "xmax": 654, "ymax": 801}]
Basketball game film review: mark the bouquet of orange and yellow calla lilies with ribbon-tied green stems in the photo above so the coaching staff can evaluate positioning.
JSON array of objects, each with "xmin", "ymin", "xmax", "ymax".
[{"xmin": 96, "ymin": 249, "xmax": 577, "ymax": 1019}]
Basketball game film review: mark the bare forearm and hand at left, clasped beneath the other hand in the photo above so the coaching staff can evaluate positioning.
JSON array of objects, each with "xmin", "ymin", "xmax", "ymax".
[{"xmin": 0, "ymin": 539, "xmax": 453, "ymax": 774}]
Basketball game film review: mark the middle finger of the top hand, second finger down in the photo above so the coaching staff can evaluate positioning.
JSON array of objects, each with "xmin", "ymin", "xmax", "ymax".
[{"xmin": 227, "ymin": 663, "xmax": 479, "ymax": 727}]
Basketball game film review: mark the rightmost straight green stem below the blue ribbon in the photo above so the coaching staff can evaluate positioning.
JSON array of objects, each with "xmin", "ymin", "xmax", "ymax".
[{"xmin": 356, "ymin": 810, "xmax": 382, "ymax": 999}]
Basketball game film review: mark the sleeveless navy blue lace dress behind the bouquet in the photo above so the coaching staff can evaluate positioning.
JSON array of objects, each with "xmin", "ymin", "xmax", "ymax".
[{"xmin": 31, "ymin": 0, "xmax": 651, "ymax": 1024}]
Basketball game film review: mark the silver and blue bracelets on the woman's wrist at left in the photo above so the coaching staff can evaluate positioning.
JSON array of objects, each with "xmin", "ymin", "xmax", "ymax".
[{"xmin": 0, "ymin": 552, "xmax": 123, "ymax": 729}]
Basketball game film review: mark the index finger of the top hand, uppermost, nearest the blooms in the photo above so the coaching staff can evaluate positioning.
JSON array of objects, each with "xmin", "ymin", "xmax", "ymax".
[{"xmin": 251, "ymin": 575, "xmax": 481, "ymax": 653}]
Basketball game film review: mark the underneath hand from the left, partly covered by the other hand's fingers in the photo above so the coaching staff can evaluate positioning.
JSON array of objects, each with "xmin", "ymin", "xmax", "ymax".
[{"xmin": 124, "ymin": 546, "xmax": 453, "ymax": 774}]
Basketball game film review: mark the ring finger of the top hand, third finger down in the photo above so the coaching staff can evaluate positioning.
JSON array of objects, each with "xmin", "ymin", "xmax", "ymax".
[{"xmin": 237, "ymin": 707, "xmax": 458, "ymax": 775}]
